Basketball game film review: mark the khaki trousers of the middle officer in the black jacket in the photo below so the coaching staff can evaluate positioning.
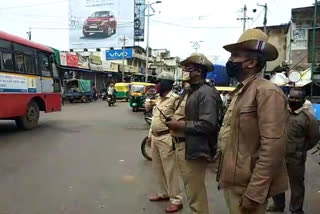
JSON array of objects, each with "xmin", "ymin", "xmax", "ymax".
[{"xmin": 175, "ymin": 143, "xmax": 209, "ymax": 214}]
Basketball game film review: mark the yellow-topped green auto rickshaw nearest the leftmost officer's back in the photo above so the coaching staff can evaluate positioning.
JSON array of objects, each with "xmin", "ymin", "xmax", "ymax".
[{"xmin": 130, "ymin": 82, "xmax": 155, "ymax": 112}]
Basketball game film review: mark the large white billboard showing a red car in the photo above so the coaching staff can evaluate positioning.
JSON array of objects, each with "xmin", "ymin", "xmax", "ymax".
[{"xmin": 69, "ymin": 0, "xmax": 135, "ymax": 49}]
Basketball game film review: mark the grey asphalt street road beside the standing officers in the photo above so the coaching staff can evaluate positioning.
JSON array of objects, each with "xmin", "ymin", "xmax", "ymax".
[{"xmin": 0, "ymin": 101, "xmax": 320, "ymax": 214}]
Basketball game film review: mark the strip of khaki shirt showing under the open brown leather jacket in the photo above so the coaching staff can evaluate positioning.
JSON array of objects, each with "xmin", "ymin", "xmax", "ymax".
[{"xmin": 218, "ymin": 76, "xmax": 255, "ymax": 152}]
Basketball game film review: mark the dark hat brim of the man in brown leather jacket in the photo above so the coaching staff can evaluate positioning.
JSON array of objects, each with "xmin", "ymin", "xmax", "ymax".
[{"xmin": 223, "ymin": 40, "xmax": 279, "ymax": 61}]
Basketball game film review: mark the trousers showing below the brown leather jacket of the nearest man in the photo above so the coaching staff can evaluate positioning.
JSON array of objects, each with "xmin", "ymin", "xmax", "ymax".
[{"xmin": 224, "ymin": 188, "xmax": 267, "ymax": 214}]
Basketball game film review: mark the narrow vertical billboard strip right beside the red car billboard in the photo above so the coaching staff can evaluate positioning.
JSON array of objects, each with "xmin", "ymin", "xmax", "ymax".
[{"xmin": 134, "ymin": 0, "xmax": 146, "ymax": 42}]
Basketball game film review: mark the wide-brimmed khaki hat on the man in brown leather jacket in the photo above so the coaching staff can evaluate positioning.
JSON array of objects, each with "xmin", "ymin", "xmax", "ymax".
[{"xmin": 223, "ymin": 29, "xmax": 279, "ymax": 61}]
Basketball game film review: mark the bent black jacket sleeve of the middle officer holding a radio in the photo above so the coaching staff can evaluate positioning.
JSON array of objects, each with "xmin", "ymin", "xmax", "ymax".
[{"xmin": 185, "ymin": 93, "xmax": 218, "ymax": 135}]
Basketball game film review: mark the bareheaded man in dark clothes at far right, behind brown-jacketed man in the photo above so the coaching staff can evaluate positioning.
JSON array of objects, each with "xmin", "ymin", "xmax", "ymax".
[{"xmin": 268, "ymin": 88, "xmax": 320, "ymax": 214}]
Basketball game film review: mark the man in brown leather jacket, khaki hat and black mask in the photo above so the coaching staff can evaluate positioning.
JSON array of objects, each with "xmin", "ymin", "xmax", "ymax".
[{"xmin": 217, "ymin": 29, "xmax": 288, "ymax": 214}]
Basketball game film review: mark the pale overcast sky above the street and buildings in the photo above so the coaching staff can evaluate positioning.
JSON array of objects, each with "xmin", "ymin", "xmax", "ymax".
[{"xmin": 0, "ymin": 0, "xmax": 314, "ymax": 64}]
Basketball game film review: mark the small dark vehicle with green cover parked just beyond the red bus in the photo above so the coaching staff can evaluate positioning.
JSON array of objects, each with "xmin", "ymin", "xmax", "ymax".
[{"xmin": 62, "ymin": 79, "xmax": 93, "ymax": 103}]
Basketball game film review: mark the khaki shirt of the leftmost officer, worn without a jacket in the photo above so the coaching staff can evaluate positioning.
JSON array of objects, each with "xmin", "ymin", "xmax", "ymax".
[{"xmin": 150, "ymin": 91, "xmax": 179, "ymax": 137}]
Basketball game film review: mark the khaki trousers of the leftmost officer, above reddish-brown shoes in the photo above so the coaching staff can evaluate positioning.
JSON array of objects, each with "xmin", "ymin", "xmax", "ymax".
[{"xmin": 152, "ymin": 134, "xmax": 182, "ymax": 204}]
